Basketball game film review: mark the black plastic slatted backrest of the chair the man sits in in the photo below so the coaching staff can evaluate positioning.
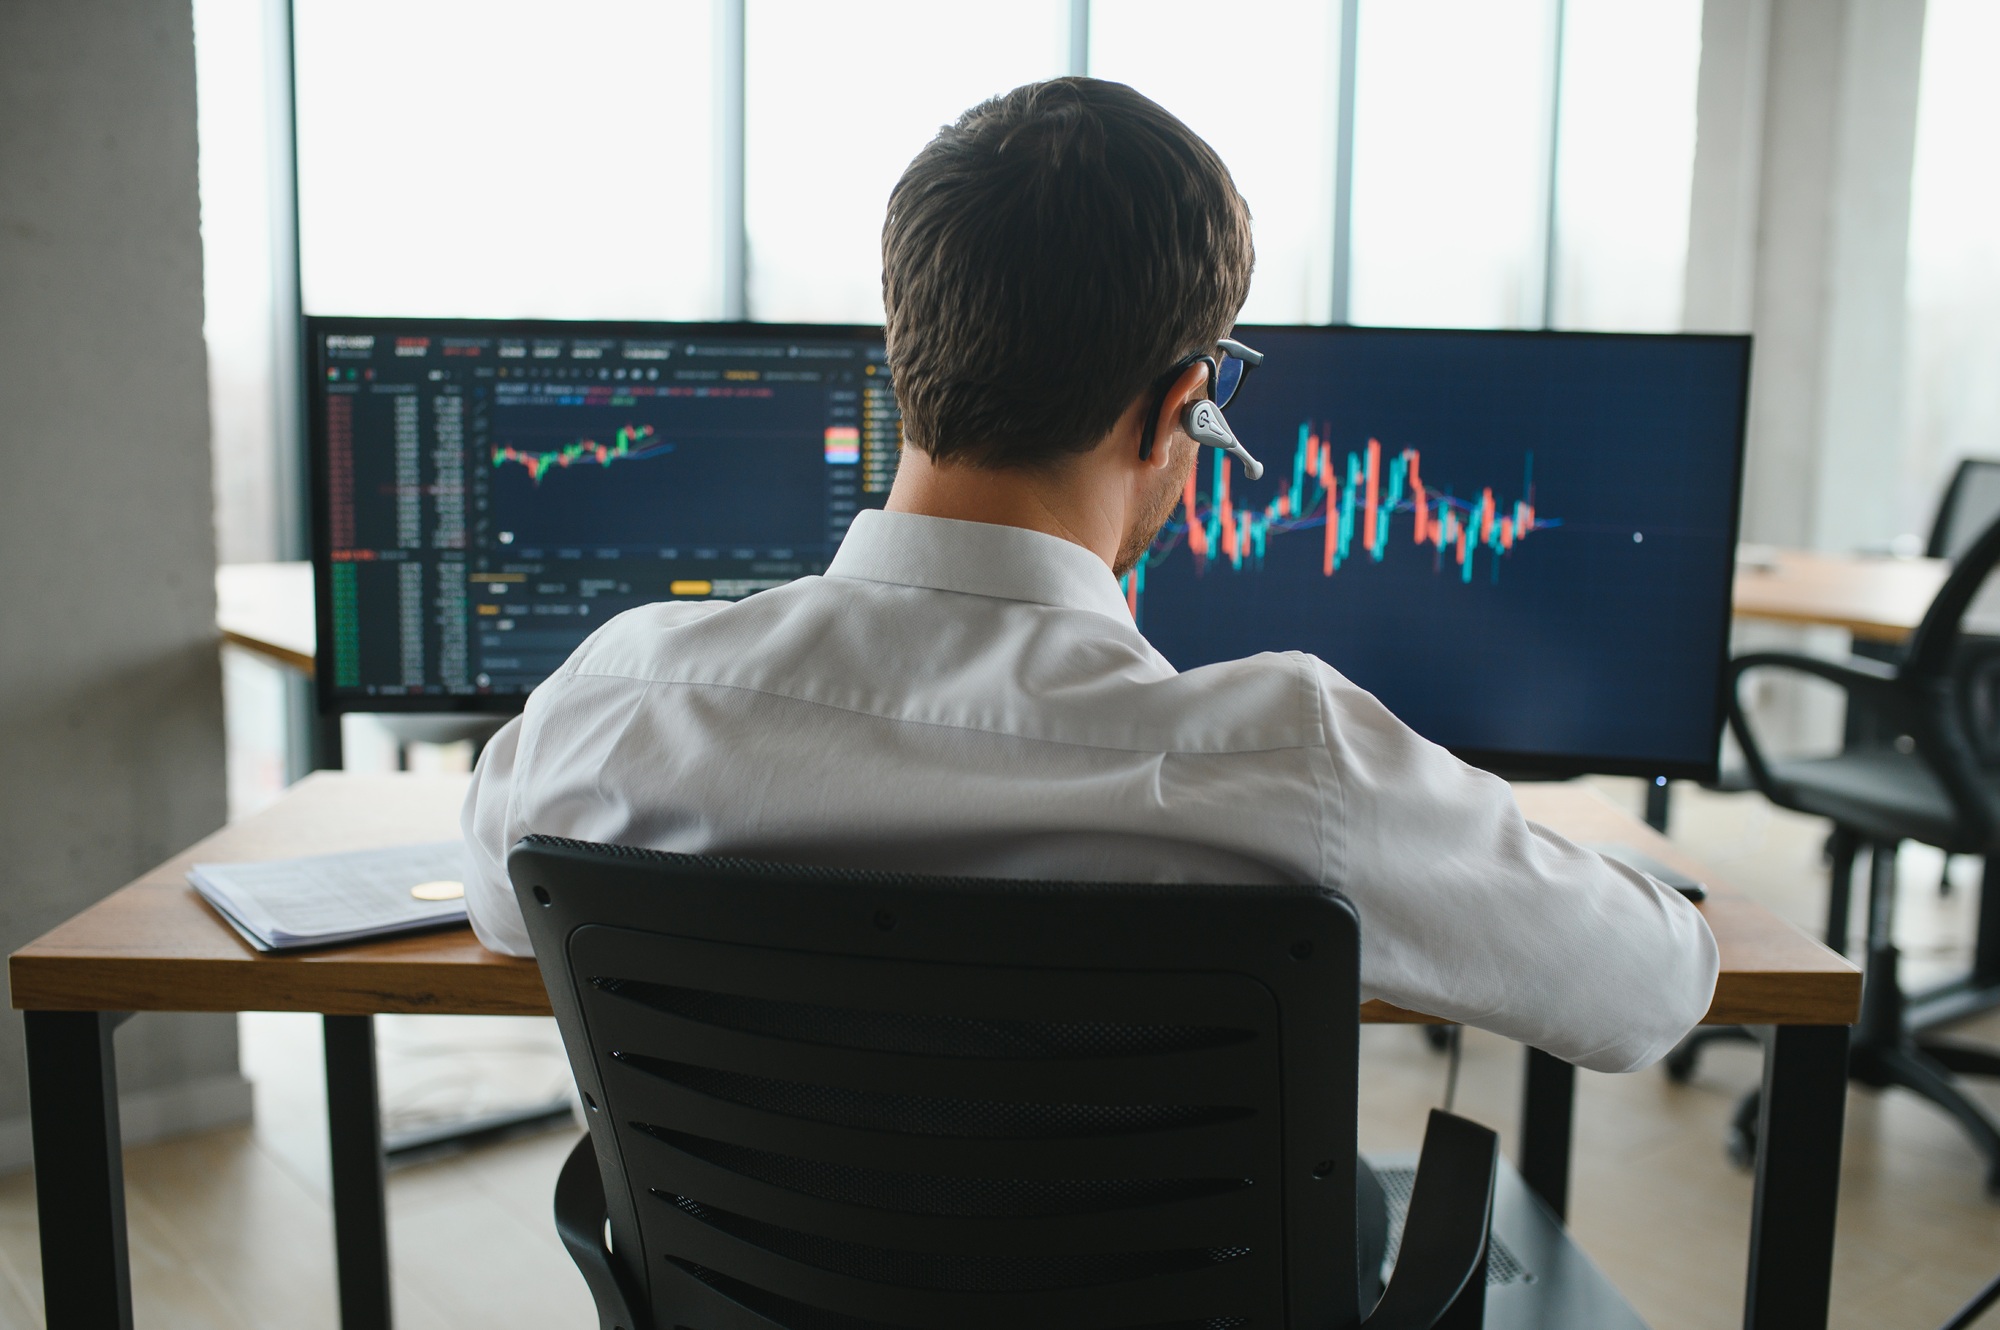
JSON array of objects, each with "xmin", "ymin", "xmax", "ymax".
[{"xmin": 508, "ymin": 836, "xmax": 1360, "ymax": 1330}]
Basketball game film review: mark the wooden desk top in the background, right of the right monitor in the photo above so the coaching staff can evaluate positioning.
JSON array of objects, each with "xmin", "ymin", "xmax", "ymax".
[{"xmin": 1736, "ymin": 548, "xmax": 1950, "ymax": 642}]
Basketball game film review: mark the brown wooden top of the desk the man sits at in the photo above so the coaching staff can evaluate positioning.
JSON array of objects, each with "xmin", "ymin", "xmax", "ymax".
[{"xmin": 10, "ymin": 772, "xmax": 1860, "ymax": 1024}]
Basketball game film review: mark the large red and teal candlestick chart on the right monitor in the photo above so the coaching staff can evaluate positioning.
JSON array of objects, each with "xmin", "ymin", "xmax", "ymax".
[{"xmin": 1122, "ymin": 422, "xmax": 1562, "ymax": 622}]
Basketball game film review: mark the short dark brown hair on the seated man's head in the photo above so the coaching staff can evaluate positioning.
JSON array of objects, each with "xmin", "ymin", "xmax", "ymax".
[{"xmin": 882, "ymin": 78, "xmax": 1252, "ymax": 468}]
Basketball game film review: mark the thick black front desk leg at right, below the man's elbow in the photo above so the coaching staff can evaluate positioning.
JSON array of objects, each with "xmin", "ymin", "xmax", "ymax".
[{"xmin": 1744, "ymin": 1026, "xmax": 1848, "ymax": 1330}]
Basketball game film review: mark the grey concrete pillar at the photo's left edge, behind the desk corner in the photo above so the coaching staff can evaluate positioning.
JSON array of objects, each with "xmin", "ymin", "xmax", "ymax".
[{"xmin": 0, "ymin": 0, "xmax": 250, "ymax": 1168}]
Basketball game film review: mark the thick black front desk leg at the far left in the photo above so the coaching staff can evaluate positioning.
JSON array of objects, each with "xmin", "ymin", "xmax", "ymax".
[{"xmin": 24, "ymin": 1012, "xmax": 132, "ymax": 1330}]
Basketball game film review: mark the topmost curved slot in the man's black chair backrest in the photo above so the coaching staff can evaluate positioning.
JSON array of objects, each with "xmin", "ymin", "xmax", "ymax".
[{"xmin": 592, "ymin": 978, "xmax": 1252, "ymax": 1058}]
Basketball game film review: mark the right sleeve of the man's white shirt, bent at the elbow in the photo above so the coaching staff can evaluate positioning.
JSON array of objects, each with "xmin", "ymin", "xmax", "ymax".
[{"xmin": 1312, "ymin": 660, "xmax": 1720, "ymax": 1072}]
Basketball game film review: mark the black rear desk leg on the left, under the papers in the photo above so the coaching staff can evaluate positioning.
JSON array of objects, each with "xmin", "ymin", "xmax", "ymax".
[{"xmin": 322, "ymin": 1016, "xmax": 390, "ymax": 1330}]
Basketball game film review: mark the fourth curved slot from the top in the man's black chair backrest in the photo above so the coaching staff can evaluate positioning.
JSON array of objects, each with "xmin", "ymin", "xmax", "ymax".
[{"xmin": 654, "ymin": 1192, "xmax": 1250, "ymax": 1294}]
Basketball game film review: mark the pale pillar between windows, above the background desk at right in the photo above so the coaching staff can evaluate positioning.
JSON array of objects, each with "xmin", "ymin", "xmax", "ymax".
[{"xmin": 1684, "ymin": 0, "xmax": 1924, "ymax": 550}]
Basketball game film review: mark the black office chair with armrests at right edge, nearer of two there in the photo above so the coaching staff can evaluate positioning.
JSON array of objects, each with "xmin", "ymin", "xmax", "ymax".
[{"xmin": 1668, "ymin": 508, "xmax": 2000, "ymax": 1194}]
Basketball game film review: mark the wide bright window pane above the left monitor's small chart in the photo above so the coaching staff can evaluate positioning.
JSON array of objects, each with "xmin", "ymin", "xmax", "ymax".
[{"xmin": 294, "ymin": 0, "xmax": 722, "ymax": 318}]
